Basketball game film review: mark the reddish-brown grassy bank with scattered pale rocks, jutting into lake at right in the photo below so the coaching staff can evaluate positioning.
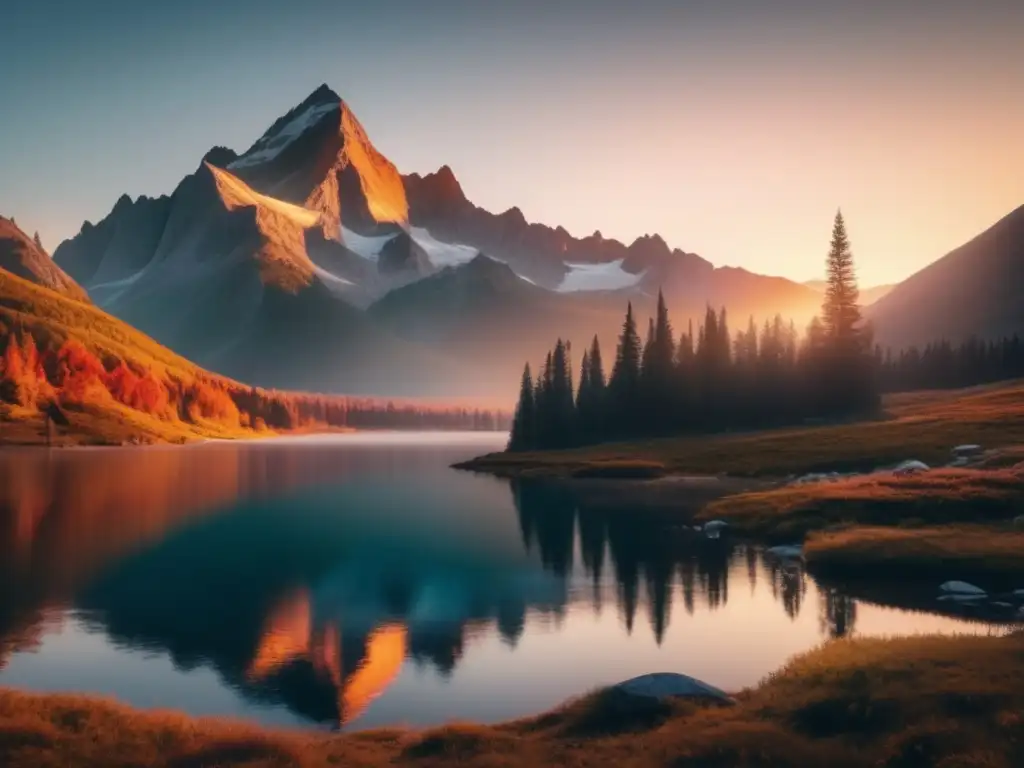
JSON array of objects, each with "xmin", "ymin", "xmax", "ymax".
[{"xmin": 698, "ymin": 467, "xmax": 1024, "ymax": 593}]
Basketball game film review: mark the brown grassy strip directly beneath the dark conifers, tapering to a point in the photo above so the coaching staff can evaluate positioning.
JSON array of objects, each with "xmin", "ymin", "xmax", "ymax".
[{"xmin": 458, "ymin": 382, "xmax": 1024, "ymax": 477}]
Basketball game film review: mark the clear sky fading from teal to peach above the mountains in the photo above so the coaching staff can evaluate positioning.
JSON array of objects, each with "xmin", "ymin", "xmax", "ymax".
[{"xmin": 0, "ymin": 0, "xmax": 1024, "ymax": 286}]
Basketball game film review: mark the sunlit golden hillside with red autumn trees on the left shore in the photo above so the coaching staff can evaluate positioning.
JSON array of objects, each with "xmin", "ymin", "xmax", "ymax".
[{"xmin": 0, "ymin": 269, "xmax": 504, "ymax": 444}]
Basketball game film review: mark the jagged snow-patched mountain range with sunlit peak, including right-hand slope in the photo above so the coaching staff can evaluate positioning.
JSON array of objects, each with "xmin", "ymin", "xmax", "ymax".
[{"xmin": 8, "ymin": 81, "xmax": 1024, "ymax": 396}]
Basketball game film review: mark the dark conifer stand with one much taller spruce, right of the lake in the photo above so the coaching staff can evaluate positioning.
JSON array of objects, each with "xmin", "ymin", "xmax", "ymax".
[{"xmin": 508, "ymin": 213, "xmax": 1024, "ymax": 451}]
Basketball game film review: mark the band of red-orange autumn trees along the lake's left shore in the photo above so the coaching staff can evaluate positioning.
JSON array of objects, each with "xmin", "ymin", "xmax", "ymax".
[{"xmin": 0, "ymin": 329, "xmax": 509, "ymax": 431}]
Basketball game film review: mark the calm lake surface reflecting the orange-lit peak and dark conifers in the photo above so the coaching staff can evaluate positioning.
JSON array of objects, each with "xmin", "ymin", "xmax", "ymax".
[{"xmin": 0, "ymin": 434, "xmax": 1007, "ymax": 729}]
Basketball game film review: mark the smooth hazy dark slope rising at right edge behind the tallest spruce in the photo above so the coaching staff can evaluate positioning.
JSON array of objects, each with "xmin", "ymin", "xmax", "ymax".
[{"xmin": 866, "ymin": 206, "xmax": 1024, "ymax": 348}]
